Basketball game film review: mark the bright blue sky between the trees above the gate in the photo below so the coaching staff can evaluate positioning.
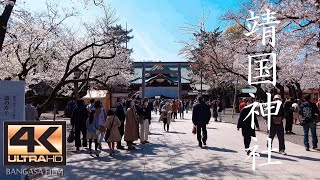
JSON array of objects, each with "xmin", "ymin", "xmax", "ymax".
[{"xmin": 26, "ymin": 0, "xmax": 235, "ymax": 61}]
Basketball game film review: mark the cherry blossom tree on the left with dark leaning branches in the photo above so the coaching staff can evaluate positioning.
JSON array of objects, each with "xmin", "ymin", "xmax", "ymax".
[{"xmin": 0, "ymin": 1, "xmax": 132, "ymax": 113}]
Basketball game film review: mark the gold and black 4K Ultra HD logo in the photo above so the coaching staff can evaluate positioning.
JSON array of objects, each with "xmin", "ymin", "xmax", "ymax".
[{"xmin": 4, "ymin": 121, "xmax": 66, "ymax": 166}]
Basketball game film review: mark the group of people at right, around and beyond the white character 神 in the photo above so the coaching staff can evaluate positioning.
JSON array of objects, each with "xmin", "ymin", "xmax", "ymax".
[{"xmin": 237, "ymin": 95, "xmax": 320, "ymax": 155}]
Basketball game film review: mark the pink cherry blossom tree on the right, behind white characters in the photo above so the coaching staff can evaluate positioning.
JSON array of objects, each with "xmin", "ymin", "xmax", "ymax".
[{"xmin": 182, "ymin": 0, "xmax": 319, "ymax": 98}]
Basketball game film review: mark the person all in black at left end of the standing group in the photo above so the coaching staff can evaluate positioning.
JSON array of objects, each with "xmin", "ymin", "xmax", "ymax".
[{"xmin": 71, "ymin": 100, "xmax": 88, "ymax": 151}]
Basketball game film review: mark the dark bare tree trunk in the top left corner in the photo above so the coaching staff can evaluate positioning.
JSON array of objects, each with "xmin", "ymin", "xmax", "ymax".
[{"xmin": 0, "ymin": 0, "xmax": 16, "ymax": 51}]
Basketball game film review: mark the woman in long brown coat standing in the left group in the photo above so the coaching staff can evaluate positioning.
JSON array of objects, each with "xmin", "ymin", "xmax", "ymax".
[{"xmin": 124, "ymin": 100, "xmax": 139, "ymax": 150}]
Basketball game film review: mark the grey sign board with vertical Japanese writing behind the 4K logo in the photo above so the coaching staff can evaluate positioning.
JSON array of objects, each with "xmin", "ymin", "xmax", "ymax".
[{"xmin": 0, "ymin": 81, "xmax": 25, "ymax": 179}]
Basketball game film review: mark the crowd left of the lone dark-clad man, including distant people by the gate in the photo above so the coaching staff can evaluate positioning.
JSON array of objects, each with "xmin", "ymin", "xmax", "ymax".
[{"xmin": 71, "ymin": 98, "xmax": 210, "ymax": 156}]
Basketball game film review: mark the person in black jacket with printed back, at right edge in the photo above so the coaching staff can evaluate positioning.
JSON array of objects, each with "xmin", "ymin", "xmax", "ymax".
[{"xmin": 300, "ymin": 94, "xmax": 320, "ymax": 151}]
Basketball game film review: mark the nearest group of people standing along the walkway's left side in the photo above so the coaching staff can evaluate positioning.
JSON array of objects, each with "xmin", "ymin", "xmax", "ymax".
[{"xmin": 71, "ymin": 98, "xmax": 153, "ymax": 156}]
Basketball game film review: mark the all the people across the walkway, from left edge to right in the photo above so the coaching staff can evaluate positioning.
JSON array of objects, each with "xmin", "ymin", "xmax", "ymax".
[{"xmin": 26, "ymin": 92, "xmax": 320, "ymax": 156}]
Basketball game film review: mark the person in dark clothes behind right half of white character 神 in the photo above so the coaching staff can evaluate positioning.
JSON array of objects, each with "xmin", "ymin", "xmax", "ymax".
[{"xmin": 269, "ymin": 95, "xmax": 286, "ymax": 155}]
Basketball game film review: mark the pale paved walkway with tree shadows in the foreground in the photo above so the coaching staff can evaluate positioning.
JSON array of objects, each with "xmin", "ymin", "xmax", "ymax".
[{"xmin": 39, "ymin": 114, "xmax": 320, "ymax": 180}]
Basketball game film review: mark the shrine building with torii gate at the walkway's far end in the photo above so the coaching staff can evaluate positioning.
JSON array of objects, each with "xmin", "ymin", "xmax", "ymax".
[{"xmin": 130, "ymin": 62, "xmax": 193, "ymax": 98}]
